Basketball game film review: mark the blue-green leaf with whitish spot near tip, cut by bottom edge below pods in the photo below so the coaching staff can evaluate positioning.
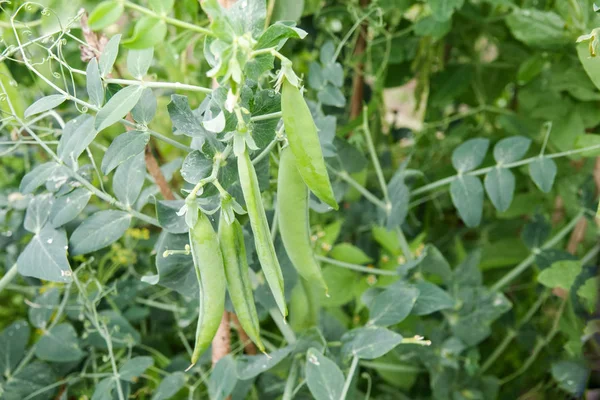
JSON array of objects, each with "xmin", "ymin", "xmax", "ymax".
[{"xmin": 304, "ymin": 347, "xmax": 344, "ymax": 400}]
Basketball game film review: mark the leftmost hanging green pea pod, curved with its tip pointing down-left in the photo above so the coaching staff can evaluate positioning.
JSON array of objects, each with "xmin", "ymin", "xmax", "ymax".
[{"xmin": 190, "ymin": 213, "xmax": 226, "ymax": 367}]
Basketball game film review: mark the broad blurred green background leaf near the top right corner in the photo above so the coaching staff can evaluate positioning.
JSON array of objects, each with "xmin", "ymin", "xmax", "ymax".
[{"xmin": 506, "ymin": 8, "xmax": 570, "ymax": 48}]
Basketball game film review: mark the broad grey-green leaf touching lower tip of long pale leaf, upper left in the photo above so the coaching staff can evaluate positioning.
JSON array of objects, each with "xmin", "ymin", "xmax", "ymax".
[{"xmin": 56, "ymin": 114, "xmax": 98, "ymax": 166}]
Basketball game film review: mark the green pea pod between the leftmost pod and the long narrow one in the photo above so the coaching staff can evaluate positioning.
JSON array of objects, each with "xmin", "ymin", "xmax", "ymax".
[{"xmin": 219, "ymin": 215, "xmax": 265, "ymax": 352}]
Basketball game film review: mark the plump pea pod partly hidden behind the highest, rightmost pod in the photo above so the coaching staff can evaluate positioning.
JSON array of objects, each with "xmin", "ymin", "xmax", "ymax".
[{"xmin": 277, "ymin": 147, "xmax": 327, "ymax": 290}]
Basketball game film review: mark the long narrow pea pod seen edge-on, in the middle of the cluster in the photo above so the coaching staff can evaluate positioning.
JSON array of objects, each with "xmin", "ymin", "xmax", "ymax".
[{"xmin": 237, "ymin": 149, "xmax": 287, "ymax": 317}]
